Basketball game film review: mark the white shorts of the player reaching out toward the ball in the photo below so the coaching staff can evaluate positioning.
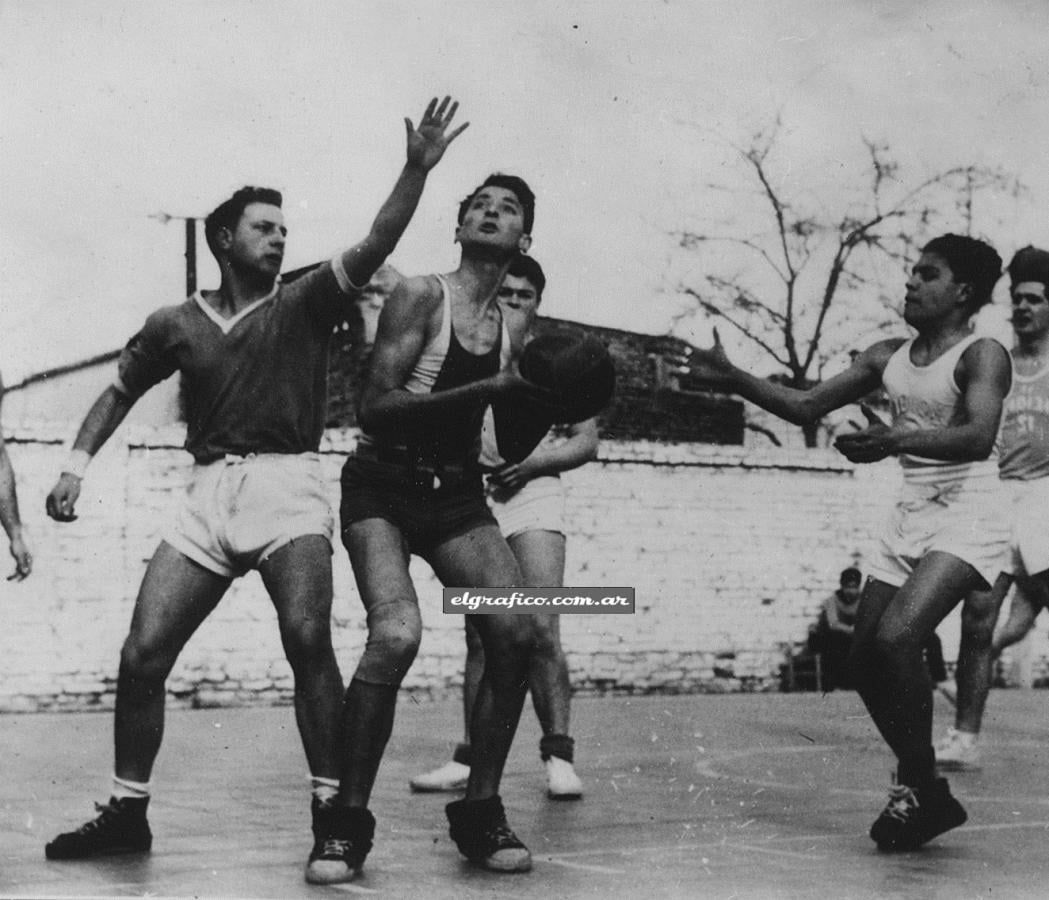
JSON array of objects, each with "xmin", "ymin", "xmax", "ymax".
[{"xmin": 868, "ymin": 469, "xmax": 1011, "ymax": 587}]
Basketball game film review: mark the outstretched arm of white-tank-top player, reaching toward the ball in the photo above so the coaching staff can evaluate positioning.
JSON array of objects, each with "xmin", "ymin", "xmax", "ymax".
[{"xmin": 678, "ymin": 328, "xmax": 902, "ymax": 425}]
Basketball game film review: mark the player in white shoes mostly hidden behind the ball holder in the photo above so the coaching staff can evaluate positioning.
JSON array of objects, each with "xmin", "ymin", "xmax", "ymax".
[{"xmin": 411, "ymin": 256, "xmax": 598, "ymax": 800}]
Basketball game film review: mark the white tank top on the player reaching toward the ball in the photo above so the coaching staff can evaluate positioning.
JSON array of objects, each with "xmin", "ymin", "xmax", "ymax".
[{"xmin": 881, "ymin": 335, "xmax": 1001, "ymax": 484}]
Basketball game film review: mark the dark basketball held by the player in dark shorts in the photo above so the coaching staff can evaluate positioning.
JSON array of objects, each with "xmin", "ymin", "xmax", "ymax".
[{"xmin": 518, "ymin": 335, "xmax": 616, "ymax": 425}]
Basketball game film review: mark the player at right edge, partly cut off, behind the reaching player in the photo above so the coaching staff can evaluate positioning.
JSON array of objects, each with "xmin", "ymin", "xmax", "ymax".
[{"xmin": 936, "ymin": 247, "xmax": 1049, "ymax": 770}]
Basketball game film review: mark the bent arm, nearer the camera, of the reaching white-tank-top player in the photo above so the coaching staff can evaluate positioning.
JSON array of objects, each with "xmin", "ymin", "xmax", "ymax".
[{"xmin": 834, "ymin": 338, "xmax": 1012, "ymax": 463}]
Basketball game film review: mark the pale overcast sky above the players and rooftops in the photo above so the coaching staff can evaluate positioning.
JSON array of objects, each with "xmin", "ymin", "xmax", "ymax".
[{"xmin": 0, "ymin": 0, "xmax": 1049, "ymax": 384}]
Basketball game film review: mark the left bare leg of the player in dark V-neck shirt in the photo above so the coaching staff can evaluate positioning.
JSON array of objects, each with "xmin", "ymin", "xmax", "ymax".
[{"xmin": 113, "ymin": 542, "xmax": 231, "ymax": 781}]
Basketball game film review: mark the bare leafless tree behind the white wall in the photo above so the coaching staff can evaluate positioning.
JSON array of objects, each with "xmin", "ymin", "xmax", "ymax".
[{"xmin": 673, "ymin": 120, "xmax": 1022, "ymax": 447}]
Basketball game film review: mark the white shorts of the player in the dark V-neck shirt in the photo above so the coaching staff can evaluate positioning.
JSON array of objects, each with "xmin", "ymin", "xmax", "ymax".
[{"xmin": 164, "ymin": 453, "xmax": 335, "ymax": 578}]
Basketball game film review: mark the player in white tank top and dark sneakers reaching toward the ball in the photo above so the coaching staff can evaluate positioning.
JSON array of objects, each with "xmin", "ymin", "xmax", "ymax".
[{"xmin": 693, "ymin": 235, "xmax": 1011, "ymax": 851}]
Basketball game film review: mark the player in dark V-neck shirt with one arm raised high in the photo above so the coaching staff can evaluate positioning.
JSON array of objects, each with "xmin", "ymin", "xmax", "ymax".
[{"xmin": 45, "ymin": 92, "xmax": 466, "ymax": 859}]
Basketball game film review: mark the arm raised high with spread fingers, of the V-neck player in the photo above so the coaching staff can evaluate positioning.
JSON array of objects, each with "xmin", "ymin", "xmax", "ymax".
[{"xmin": 342, "ymin": 97, "xmax": 470, "ymax": 287}]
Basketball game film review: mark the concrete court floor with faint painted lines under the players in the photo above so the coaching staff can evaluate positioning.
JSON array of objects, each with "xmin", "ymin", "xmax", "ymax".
[{"xmin": 0, "ymin": 690, "xmax": 1049, "ymax": 900}]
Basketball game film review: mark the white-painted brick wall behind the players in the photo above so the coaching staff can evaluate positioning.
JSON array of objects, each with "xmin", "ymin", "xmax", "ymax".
[{"xmin": 0, "ymin": 426, "xmax": 1047, "ymax": 711}]
